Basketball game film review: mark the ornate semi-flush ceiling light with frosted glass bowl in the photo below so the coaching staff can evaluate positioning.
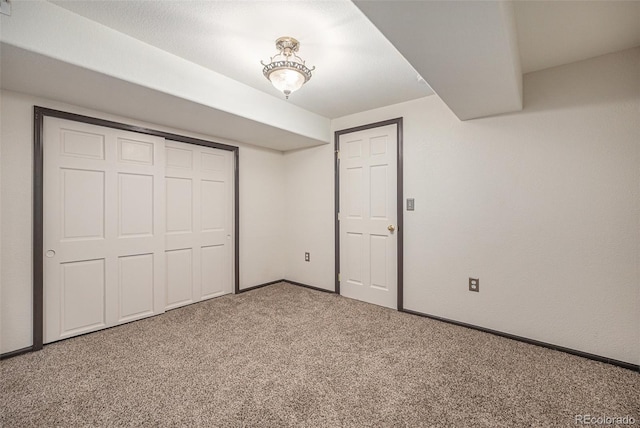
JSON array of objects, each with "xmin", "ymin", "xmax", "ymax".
[{"xmin": 260, "ymin": 37, "xmax": 316, "ymax": 99}]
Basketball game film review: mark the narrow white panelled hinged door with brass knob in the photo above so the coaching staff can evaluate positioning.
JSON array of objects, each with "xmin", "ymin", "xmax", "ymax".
[{"xmin": 338, "ymin": 124, "xmax": 398, "ymax": 309}]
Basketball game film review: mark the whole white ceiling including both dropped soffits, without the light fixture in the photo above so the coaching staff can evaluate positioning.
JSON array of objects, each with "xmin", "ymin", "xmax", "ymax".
[{"xmin": 0, "ymin": 0, "xmax": 640, "ymax": 150}]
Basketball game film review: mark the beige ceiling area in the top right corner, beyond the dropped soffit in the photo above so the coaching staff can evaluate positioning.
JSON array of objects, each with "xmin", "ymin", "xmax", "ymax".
[{"xmin": 514, "ymin": 0, "xmax": 640, "ymax": 73}]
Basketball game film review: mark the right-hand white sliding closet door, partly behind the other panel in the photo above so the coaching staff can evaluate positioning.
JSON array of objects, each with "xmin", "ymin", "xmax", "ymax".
[{"xmin": 165, "ymin": 141, "xmax": 234, "ymax": 309}]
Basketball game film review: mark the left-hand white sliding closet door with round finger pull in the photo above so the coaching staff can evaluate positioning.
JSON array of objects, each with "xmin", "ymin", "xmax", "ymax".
[{"xmin": 44, "ymin": 117, "xmax": 165, "ymax": 343}]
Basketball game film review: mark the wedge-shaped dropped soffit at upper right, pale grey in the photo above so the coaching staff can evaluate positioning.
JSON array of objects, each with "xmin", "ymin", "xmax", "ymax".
[{"xmin": 354, "ymin": 0, "xmax": 522, "ymax": 120}]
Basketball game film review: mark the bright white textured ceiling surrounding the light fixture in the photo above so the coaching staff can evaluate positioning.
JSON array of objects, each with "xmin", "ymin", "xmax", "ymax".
[{"xmin": 54, "ymin": 0, "xmax": 433, "ymax": 118}]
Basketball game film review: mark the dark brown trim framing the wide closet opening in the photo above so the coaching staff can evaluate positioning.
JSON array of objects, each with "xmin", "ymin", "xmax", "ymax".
[{"xmin": 31, "ymin": 106, "xmax": 240, "ymax": 353}]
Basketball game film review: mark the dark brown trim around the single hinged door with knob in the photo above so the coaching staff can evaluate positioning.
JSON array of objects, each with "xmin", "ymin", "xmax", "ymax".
[{"xmin": 334, "ymin": 117, "xmax": 404, "ymax": 311}]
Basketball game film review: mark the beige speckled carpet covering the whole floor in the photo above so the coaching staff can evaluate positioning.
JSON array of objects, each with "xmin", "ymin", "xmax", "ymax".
[{"xmin": 0, "ymin": 284, "xmax": 640, "ymax": 427}]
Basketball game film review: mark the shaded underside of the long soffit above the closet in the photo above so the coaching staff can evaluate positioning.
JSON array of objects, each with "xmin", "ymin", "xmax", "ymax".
[{"xmin": 0, "ymin": 43, "xmax": 329, "ymax": 151}]
